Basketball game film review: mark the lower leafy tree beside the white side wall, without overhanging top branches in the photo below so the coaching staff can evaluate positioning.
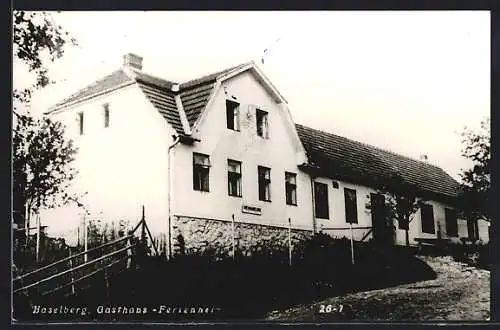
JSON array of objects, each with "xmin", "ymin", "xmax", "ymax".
[{"xmin": 12, "ymin": 115, "xmax": 84, "ymax": 227}]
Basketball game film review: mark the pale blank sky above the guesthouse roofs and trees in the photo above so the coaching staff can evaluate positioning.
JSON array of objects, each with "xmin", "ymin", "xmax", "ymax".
[{"xmin": 14, "ymin": 11, "xmax": 490, "ymax": 178}]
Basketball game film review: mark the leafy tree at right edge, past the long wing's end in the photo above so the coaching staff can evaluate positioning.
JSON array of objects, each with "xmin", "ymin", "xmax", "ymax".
[{"xmin": 461, "ymin": 118, "xmax": 492, "ymax": 227}]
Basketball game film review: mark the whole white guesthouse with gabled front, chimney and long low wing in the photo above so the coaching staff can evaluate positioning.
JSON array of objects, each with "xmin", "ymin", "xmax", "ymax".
[{"xmin": 44, "ymin": 54, "xmax": 487, "ymax": 255}]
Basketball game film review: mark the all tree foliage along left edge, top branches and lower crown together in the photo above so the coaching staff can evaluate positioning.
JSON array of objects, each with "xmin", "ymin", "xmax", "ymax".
[{"xmin": 12, "ymin": 11, "xmax": 81, "ymax": 232}]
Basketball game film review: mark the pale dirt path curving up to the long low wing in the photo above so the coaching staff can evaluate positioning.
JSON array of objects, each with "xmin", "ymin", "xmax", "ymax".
[{"xmin": 267, "ymin": 257, "xmax": 490, "ymax": 322}]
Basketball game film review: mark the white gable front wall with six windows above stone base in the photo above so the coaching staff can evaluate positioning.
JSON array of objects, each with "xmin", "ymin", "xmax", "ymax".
[{"xmin": 173, "ymin": 71, "xmax": 312, "ymax": 230}]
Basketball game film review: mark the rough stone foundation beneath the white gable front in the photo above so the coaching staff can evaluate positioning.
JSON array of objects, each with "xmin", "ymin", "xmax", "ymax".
[{"xmin": 172, "ymin": 217, "xmax": 312, "ymax": 257}]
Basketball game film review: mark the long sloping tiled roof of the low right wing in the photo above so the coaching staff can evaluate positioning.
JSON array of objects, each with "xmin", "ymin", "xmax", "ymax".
[{"xmin": 296, "ymin": 124, "xmax": 459, "ymax": 198}]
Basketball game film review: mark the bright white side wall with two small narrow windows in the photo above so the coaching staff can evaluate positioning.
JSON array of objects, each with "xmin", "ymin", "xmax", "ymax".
[{"xmin": 43, "ymin": 85, "xmax": 173, "ymax": 242}]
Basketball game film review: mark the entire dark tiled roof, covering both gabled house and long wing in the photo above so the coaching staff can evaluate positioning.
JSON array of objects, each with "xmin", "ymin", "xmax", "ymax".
[{"xmin": 47, "ymin": 62, "xmax": 459, "ymax": 198}]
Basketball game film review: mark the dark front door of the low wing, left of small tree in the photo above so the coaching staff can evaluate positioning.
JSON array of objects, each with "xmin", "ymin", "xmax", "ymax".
[{"xmin": 370, "ymin": 193, "xmax": 394, "ymax": 245}]
